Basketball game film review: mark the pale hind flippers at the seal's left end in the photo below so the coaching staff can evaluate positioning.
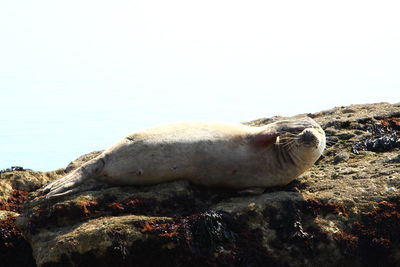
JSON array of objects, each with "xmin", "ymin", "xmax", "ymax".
[{"xmin": 43, "ymin": 158, "xmax": 104, "ymax": 198}]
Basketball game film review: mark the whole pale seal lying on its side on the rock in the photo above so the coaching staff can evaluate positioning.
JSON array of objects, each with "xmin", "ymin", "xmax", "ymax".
[{"xmin": 43, "ymin": 117, "xmax": 326, "ymax": 198}]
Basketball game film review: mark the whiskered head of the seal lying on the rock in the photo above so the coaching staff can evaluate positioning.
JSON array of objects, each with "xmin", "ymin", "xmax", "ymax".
[{"xmin": 275, "ymin": 117, "xmax": 326, "ymax": 169}]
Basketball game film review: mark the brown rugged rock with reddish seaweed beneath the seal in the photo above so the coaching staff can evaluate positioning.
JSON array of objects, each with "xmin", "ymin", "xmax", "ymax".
[{"xmin": 0, "ymin": 103, "xmax": 400, "ymax": 266}]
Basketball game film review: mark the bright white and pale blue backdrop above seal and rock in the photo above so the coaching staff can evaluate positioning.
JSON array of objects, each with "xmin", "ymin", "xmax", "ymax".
[{"xmin": 0, "ymin": 0, "xmax": 400, "ymax": 170}]
